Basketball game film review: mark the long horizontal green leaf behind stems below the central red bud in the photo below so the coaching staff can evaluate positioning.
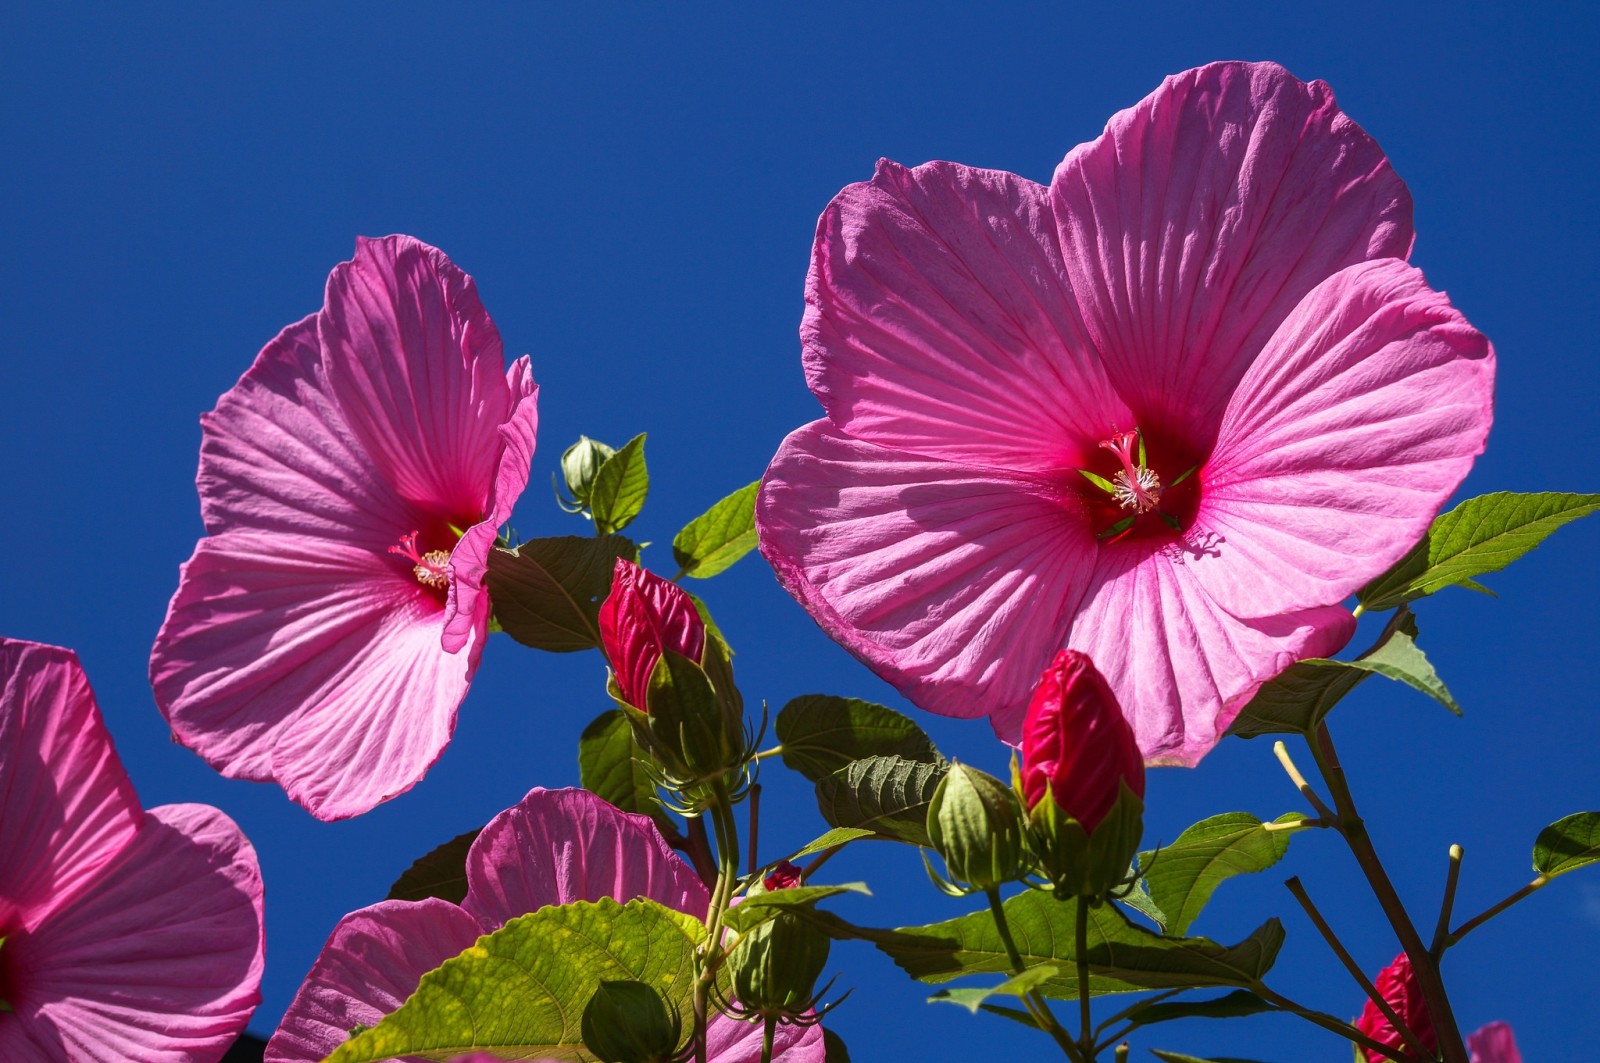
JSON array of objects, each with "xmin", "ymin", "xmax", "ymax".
[{"xmin": 832, "ymin": 890, "xmax": 1283, "ymax": 999}]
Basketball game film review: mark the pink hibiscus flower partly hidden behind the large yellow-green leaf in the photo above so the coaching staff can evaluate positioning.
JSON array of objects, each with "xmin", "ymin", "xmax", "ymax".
[{"xmin": 266, "ymin": 789, "xmax": 824, "ymax": 1063}]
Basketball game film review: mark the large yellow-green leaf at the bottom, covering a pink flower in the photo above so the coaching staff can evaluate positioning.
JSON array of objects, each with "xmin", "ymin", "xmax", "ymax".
[{"xmin": 328, "ymin": 898, "xmax": 706, "ymax": 1063}]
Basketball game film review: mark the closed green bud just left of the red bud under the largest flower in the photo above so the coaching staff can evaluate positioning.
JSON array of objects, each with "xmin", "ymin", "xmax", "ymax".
[{"xmin": 928, "ymin": 764, "xmax": 1027, "ymax": 890}]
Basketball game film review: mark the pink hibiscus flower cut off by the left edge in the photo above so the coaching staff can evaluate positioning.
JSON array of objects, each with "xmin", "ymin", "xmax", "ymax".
[{"xmin": 0, "ymin": 639, "xmax": 262, "ymax": 1063}]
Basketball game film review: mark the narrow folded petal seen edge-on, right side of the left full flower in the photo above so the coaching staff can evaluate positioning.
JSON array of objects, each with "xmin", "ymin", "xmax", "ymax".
[{"xmin": 443, "ymin": 355, "xmax": 539, "ymax": 653}]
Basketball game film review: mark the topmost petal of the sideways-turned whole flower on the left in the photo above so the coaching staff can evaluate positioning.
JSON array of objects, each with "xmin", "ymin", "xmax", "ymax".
[{"xmin": 317, "ymin": 235, "xmax": 508, "ymax": 528}]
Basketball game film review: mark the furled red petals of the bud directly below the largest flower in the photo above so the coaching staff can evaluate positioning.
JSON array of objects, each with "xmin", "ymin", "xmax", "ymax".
[{"xmin": 1022, "ymin": 650, "xmax": 1144, "ymax": 832}]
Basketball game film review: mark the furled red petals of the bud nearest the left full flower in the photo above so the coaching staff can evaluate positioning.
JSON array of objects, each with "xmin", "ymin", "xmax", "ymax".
[{"xmin": 600, "ymin": 557, "xmax": 706, "ymax": 711}]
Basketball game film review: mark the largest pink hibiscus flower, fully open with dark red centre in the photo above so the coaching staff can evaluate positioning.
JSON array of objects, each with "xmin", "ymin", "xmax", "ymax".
[{"xmin": 757, "ymin": 62, "xmax": 1493, "ymax": 764}]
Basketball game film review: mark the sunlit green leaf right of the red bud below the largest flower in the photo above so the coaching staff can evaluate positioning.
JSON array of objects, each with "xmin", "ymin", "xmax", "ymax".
[{"xmin": 1139, "ymin": 812, "xmax": 1306, "ymax": 937}]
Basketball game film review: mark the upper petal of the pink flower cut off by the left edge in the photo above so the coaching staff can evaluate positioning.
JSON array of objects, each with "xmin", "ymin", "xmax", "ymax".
[{"xmin": 0, "ymin": 639, "xmax": 144, "ymax": 933}]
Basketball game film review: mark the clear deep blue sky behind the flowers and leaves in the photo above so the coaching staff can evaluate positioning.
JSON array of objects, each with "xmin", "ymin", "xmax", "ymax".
[{"xmin": 0, "ymin": 2, "xmax": 1600, "ymax": 1061}]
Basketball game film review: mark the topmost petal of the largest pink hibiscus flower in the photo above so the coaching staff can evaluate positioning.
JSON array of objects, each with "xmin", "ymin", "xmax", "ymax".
[{"xmin": 1050, "ymin": 62, "xmax": 1411, "ymax": 434}]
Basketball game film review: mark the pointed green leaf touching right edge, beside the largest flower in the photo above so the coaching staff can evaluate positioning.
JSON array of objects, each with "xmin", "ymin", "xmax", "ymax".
[{"xmin": 1357, "ymin": 491, "xmax": 1600, "ymax": 608}]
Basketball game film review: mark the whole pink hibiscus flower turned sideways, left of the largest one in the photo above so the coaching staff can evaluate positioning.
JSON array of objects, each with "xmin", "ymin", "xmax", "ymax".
[{"xmin": 150, "ymin": 237, "xmax": 538, "ymax": 820}]
